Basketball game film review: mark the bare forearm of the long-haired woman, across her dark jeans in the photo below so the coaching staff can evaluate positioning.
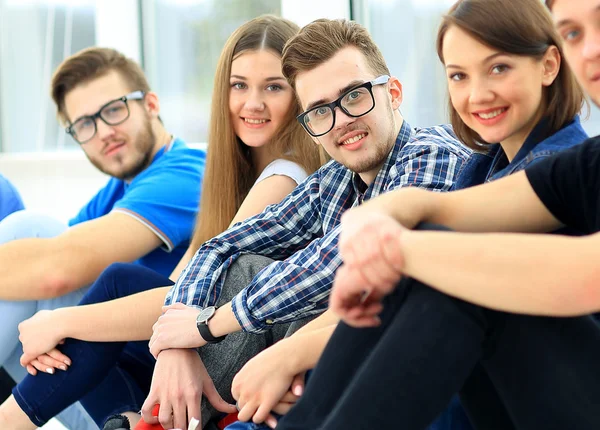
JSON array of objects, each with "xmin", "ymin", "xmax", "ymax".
[{"xmin": 53, "ymin": 287, "xmax": 170, "ymax": 342}]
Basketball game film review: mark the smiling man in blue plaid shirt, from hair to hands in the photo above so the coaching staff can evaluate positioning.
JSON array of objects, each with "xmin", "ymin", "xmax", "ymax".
[{"xmin": 136, "ymin": 20, "xmax": 470, "ymax": 428}]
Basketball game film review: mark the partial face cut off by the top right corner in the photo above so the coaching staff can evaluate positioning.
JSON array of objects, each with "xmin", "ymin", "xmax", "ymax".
[{"xmin": 552, "ymin": 0, "xmax": 600, "ymax": 106}]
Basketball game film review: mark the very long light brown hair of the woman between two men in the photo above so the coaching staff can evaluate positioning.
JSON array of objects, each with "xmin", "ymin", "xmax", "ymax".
[{"xmin": 192, "ymin": 15, "xmax": 321, "ymax": 249}]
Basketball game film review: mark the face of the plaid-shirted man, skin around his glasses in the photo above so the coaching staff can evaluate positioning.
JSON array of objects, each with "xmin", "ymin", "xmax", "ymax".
[{"xmin": 296, "ymin": 47, "xmax": 402, "ymax": 184}]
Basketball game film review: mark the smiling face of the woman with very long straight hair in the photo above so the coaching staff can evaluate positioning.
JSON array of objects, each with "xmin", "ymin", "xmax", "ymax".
[{"xmin": 229, "ymin": 50, "xmax": 294, "ymax": 148}]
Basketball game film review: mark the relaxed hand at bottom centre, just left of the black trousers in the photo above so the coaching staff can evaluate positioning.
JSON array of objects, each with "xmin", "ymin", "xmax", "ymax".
[{"xmin": 231, "ymin": 340, "xmax": 304, "ymax": 427}]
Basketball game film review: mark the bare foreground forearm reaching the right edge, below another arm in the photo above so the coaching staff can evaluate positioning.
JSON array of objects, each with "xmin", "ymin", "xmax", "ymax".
[{"xmin": 399, "ymin": 231, "xmax": 600, "ymax": 316}]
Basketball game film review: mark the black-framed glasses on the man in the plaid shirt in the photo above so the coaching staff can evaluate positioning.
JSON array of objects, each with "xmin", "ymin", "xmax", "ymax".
[{"xmin": 297, "ymin": 75, "xmax": 390, "ymax": 137}]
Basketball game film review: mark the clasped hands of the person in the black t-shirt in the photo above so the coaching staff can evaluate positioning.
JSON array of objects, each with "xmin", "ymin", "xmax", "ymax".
[{"xmin": 329, "ymin": 211, "xmax": 407, "ymax": 327}]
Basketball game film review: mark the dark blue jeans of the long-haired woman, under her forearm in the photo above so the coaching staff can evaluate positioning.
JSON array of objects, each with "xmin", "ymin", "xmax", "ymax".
[{"xmin": 13, "ymin": 263, "xmax": 173, "ymax": 430}]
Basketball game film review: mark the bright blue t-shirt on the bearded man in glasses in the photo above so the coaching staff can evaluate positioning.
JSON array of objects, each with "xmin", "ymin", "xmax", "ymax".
[{"xmin": 69, "ymin": 139, "xmax": 206, "ymax": 276}]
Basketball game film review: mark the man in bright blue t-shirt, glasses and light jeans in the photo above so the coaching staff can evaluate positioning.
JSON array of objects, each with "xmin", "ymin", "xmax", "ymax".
[{"xmin": 0, "ymin": 48, "xmax": 205, "ymax": 430}]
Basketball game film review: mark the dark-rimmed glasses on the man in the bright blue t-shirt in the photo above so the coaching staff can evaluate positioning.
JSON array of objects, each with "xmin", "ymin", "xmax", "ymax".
[{"xmin": 66, "ymin": 90, "xmax": 146, "ymax": 144}]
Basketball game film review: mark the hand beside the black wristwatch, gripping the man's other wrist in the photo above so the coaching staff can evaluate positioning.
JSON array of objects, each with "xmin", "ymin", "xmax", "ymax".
[{"xmin": 149, "ymin": 303, "xmax": 206, "ymax": 358}]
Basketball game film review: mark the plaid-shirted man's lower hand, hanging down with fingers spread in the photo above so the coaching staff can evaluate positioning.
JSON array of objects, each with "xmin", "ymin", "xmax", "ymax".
[{"xmin": 142, "ymin": 349, "xmax": 236, "ymax": 429}]
